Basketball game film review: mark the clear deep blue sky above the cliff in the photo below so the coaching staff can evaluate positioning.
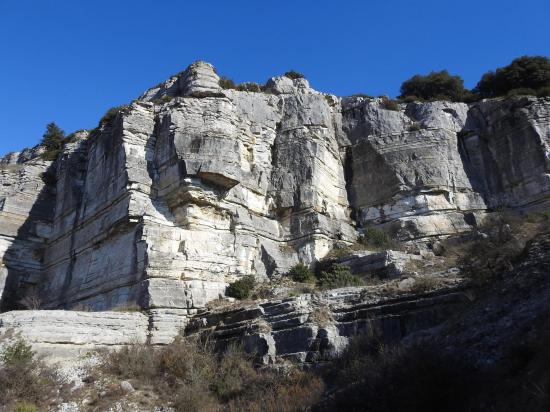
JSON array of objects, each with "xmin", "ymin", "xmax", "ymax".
[{"xmin": 0, "ymin": 0, "xmax": 550, "ymax": 154}]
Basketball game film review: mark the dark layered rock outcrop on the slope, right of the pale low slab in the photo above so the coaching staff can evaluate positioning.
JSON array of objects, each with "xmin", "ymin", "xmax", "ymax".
[{"xmin": 186, "ymin": 288, "xmax": 466, "ymax": 363}]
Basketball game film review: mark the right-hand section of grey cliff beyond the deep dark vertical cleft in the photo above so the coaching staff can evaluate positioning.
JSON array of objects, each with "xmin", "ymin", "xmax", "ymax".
[{"xmin": 342, "ymin": 97, "xmax": 550, "ymax": 240}]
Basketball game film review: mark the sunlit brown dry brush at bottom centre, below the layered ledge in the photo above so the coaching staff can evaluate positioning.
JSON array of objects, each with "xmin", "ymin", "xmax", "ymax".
[{"xmin": 101, "ymin": 339, "xmax": 323, "ymax": 411}]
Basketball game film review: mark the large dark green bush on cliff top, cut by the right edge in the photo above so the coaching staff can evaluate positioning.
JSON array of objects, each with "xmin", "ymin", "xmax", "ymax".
[{"xmin": 475, "ymin": 56, "xmax": 550, "ymax": 97}]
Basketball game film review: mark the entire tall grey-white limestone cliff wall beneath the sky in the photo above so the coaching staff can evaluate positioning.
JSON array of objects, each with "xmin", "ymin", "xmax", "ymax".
[{"xmin": 0, "ymin": 62, "xmax": 550, "ymax": 322}]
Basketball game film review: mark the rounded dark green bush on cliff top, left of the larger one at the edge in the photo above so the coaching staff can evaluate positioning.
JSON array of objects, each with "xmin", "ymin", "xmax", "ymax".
[{"xmin": 400, "ymin": 70, "xmax": 466, "ymax": 101}]
